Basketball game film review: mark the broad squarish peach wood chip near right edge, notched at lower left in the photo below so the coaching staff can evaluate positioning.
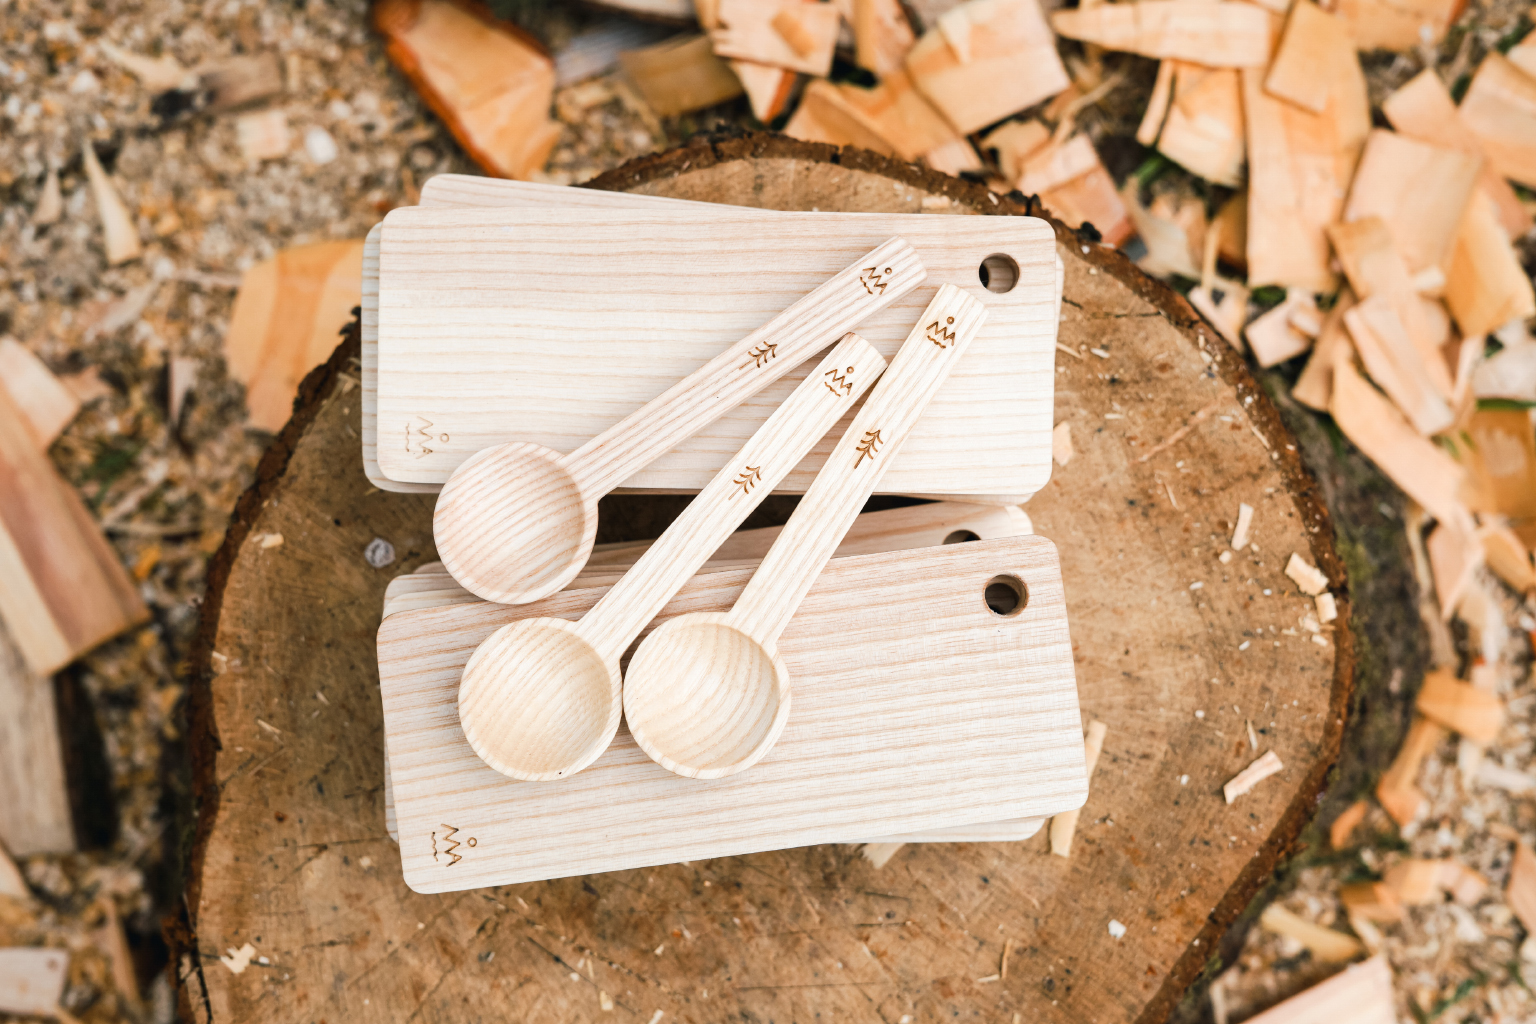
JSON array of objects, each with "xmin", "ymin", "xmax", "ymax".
[{"xmin": 1344, "ymin": 129, "xmax": 1482, "ymax": 275}]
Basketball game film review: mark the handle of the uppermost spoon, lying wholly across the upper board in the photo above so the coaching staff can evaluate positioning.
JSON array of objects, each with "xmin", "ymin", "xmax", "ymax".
[{"xmin": 564, "ymin": 238, "xmax": 928, "ymax": 496}]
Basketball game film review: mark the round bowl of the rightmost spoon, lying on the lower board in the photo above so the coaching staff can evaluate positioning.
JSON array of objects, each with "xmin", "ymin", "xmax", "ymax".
[{"xmin": 624, "ymin": 613, "xmax": 790, "ymax": 778}]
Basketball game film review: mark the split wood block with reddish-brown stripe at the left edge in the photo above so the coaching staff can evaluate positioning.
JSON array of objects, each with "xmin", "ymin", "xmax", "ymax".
[{"xmin": 0, "ymin": 380, "xmax": 149, "ymax": 676}]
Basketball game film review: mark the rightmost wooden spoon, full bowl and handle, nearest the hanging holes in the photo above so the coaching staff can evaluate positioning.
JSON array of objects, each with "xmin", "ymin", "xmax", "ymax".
[{"xmin": 624, "ymin": 284, "xmax": 986, "ymax": 778}]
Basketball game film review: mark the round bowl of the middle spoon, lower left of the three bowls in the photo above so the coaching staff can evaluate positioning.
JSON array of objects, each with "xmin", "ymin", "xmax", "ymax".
[{"xmin": 459, "ymin": 619, "xmax": 624, "ymax": 781}]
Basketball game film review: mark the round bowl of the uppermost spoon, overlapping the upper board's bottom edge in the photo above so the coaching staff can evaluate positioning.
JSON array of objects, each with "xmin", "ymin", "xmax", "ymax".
[{"xmin": 432, "ymin": 442, "xmax": 598, "ymax": 603}]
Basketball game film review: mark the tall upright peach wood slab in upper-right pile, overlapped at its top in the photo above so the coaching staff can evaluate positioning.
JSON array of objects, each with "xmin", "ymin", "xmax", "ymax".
[{"xmin": 1243, "ymin": 2, "xmax": 1370, "ymax": 292}]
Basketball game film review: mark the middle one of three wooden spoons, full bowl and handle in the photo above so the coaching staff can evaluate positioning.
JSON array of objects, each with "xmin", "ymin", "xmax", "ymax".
[{"xmin": 459, "ymin": 335, "xmax": 885, "ymax": 781}]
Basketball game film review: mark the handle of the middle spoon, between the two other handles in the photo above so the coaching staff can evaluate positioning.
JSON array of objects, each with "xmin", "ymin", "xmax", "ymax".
[{"xmin": 576, "ymin": 333, "xmax": 885, "ymax": 660}]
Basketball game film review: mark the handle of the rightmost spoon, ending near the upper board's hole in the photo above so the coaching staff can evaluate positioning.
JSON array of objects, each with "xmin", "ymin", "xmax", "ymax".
[{"xmin": 731, "ymin": 284, "xmax": 986, "ymax": 651}]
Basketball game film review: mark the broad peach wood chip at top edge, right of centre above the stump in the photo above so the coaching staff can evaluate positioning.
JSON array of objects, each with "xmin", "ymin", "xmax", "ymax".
[{"xmin": 906, "ymin": 0, "xmax": 1071, "ymax": 135}]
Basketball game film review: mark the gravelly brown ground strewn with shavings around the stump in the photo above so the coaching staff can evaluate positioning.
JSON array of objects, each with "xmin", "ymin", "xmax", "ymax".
[{"xmin": 0, "ymin": 0, "xmax": 1536, "ymax": 1022}]
